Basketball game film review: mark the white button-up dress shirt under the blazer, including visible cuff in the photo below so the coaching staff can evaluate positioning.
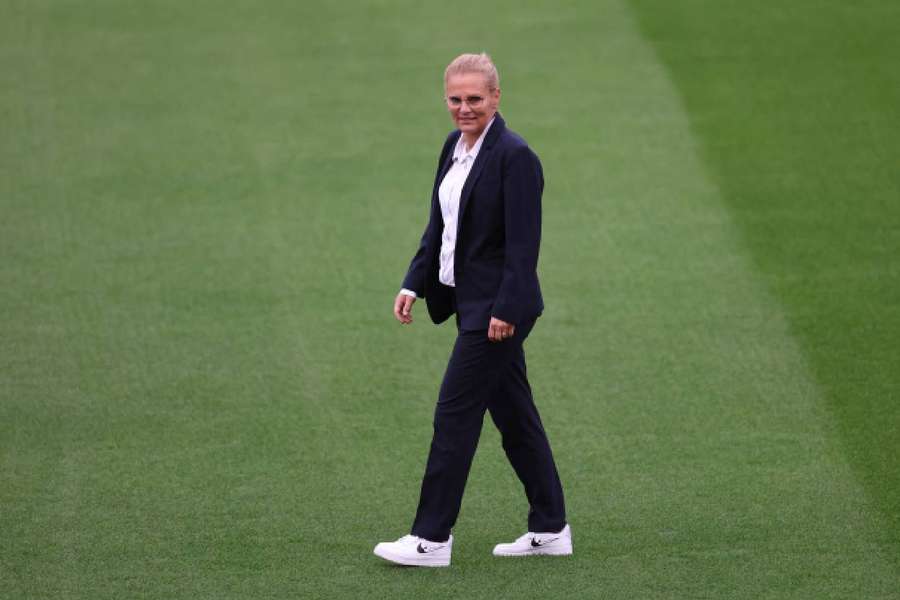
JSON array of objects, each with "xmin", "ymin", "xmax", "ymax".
[{"xmin": 400, "ymin": 119, "xmax": 494, "ymax": 297}]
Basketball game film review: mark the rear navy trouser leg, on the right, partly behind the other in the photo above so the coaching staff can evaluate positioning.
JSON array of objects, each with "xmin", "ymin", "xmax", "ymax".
[{"xmin": 487, "ymin": 347, "xmax": 566, "ymax": 531}]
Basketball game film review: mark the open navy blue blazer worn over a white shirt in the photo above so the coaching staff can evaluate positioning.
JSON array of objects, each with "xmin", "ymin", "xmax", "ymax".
[{"xmin": 403, "ymin": 113, "xmax": 544, "ymax": 330}]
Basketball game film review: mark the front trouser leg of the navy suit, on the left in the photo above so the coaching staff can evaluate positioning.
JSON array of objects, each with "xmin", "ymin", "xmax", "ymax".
[{"xmin": 412, "ymin": 324, "xmax": 531, "ymax": 541}]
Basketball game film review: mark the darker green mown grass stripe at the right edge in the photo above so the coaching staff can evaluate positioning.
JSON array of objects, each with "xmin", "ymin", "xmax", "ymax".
[{"xmin": 633, "ymin": 0, "xmax": 900, "ymax": 564}]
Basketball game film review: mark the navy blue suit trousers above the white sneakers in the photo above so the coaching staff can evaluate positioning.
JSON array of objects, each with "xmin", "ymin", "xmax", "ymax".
[{"xmin": 412, "ymin": 321, "xmax": 566, "ymax": 542}]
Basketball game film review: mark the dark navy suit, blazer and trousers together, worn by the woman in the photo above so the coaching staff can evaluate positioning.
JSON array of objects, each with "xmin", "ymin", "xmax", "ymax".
[{"xmin": 403, "ymin": 114, "xmax": 566, "ymax": 541}]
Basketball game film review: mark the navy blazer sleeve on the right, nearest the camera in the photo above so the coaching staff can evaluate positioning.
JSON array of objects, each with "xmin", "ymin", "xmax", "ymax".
[{"xmin": 492, "ymin": 145, "xmax": 544, "ymax": 323}]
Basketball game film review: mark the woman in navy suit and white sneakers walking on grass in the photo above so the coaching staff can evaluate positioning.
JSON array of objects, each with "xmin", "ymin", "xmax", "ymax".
[{"xmin": 375, "ymin": 54, "xmax": 572, "ymax": 567}]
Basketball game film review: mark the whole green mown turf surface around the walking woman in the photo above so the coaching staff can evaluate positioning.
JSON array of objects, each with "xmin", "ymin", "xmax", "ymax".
[{"xmin": 0, "ymin": 0, "xmax": 900, "ymax": 599}]
